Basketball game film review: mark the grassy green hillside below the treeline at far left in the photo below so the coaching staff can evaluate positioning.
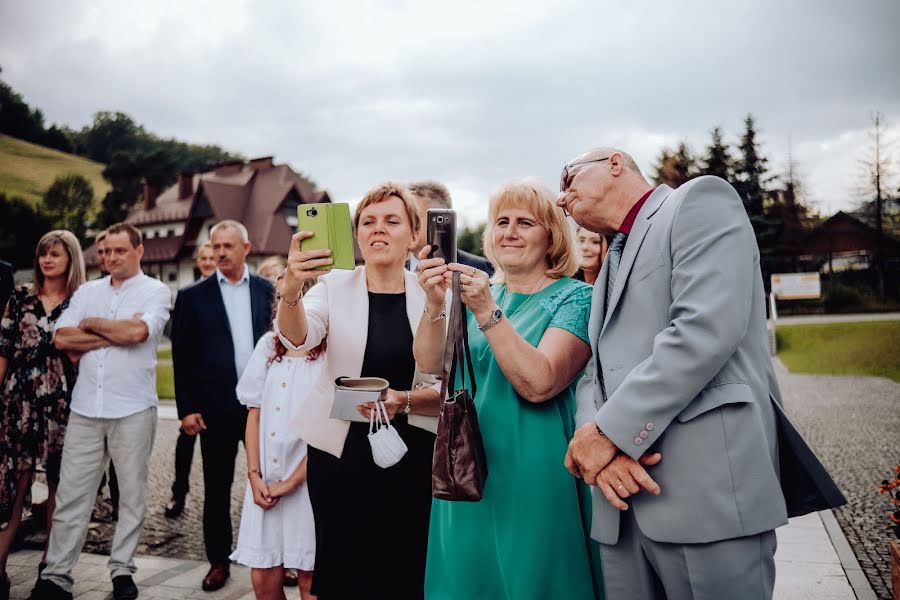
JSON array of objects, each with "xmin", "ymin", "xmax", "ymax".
[{"xmin": 0, "ymin": 134, "xmax": 110, "ymax": 208}]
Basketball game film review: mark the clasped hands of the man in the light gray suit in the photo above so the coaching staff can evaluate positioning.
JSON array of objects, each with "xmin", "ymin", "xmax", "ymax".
[{"xmin": 565, "ymin": 422, "xmax": 662, "ymax": 510}]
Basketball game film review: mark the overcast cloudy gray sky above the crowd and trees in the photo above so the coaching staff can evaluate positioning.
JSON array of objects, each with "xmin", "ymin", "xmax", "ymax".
[{"xmin": 0, "ymin": 0, "xmax": 900, "ymax": 224}]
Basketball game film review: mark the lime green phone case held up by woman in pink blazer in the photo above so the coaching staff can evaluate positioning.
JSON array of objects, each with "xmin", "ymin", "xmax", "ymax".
[{"xmin": 297, "ymin": 202, "xmax": 356, "ymax": 271}]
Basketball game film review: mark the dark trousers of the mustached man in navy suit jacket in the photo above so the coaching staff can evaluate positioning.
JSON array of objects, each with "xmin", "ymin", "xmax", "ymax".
[{"xmin": 200, "ymin": 420, "xmax": 246, "ymax": 564}]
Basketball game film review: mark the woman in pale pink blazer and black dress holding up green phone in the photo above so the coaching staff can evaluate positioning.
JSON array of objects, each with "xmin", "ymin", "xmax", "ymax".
[{"xmin": 276, "ymin": 183, "xmax": 440, "ymax": 600}]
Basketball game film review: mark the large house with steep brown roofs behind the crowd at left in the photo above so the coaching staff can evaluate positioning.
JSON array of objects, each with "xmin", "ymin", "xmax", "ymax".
[{"xmin": 85, "ymin": 156, "xmax": 331, "ymax": 293}]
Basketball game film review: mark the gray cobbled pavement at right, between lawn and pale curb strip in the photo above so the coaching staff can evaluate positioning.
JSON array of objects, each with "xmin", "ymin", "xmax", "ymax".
[{"xmin": 776, "ymin": 361, "xmax": 900, "ymax": 600}]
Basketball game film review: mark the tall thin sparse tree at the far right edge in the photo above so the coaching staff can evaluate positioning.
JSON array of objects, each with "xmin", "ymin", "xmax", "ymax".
[{"xmin": 859, "ymin": 111, "xmax": 893, "ymax": 301}]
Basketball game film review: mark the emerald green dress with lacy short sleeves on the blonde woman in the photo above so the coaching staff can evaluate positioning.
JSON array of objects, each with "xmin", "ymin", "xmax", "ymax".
[{"xmin": 425, "ymin": 277, "xmax": 604, "ymax": 600}]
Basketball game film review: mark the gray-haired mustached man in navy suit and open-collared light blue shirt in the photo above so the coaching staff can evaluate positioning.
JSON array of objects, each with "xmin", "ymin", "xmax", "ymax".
[{"xmin": 172, "ymin": 220, "xmax": 275, "ymax": 591}]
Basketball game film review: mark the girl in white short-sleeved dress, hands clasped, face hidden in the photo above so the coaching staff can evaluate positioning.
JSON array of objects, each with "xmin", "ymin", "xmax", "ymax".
[{"xmin": 231, "ymin": 332, "xmax": 325, "ymax": 600}]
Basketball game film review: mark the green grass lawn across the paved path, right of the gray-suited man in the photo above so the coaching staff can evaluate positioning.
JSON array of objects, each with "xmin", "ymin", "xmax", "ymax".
[{"xmin": 776, "ymin": 321, "xmax": 900, "ymax": 382}]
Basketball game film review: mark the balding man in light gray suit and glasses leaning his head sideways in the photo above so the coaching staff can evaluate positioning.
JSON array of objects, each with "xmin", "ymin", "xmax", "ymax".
[{"xmin": 558, "ymin": 148, "xmax": 840, "ymax": 600}]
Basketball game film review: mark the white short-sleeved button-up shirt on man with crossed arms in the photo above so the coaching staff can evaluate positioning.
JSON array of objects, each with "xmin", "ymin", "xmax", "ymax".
[{"xmin": 54, "ymin": 273, "xmax": 172, "ymax": 419}]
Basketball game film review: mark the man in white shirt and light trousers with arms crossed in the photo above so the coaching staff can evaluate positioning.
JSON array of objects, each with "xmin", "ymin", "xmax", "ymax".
[{"xmin": 32, "ymin": 223, "xmax": 171, "ymax": 600}]
